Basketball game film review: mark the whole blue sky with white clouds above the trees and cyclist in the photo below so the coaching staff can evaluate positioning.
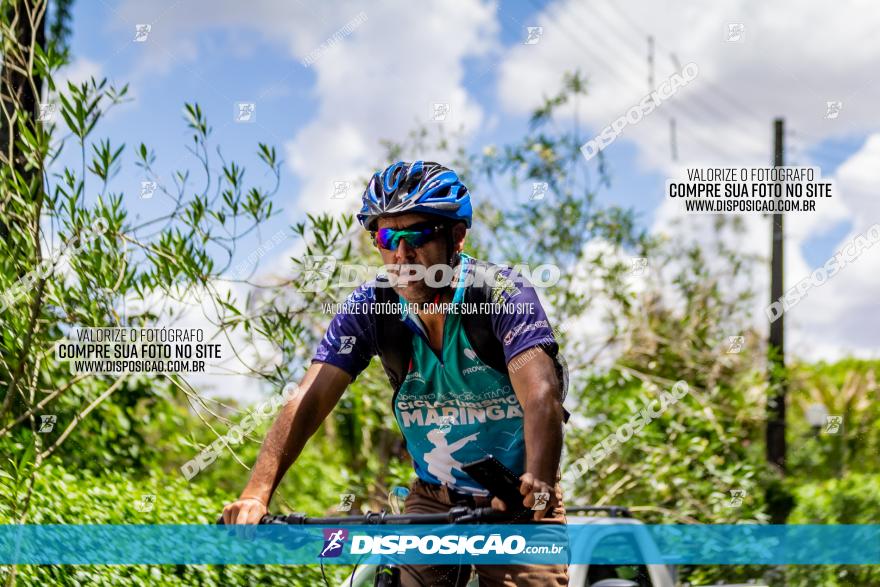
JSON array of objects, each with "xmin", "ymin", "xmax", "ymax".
[{"xmin": 51, "ymin": 0, "xmax": 880, "ymax": 400}]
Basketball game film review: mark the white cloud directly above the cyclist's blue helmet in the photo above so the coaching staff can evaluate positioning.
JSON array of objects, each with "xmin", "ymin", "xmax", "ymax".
[{"xmin": 286, "ymin": 0, "xmax": 496, "ymax": 220}]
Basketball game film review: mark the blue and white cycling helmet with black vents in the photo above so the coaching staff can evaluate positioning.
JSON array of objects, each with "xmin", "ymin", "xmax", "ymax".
[{"xmin": 357, "ymin": 161, "xmax": 473, "ymax": 230}]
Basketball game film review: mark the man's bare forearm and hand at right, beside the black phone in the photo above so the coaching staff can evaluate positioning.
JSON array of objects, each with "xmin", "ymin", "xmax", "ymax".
[{"xmin": 508, "ymin": 347, "xmax": 562, "ymax": 519}]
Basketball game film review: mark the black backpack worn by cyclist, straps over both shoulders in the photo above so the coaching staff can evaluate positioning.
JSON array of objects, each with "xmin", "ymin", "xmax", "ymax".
[{"xmin": 374, "ymin": 259, "xmax": 569, "ymax": 421}]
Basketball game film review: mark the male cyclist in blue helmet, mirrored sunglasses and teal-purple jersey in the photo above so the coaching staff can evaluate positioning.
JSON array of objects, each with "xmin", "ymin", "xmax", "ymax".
[{"xmin": 223, "ymin": 161, "xmax": 568, "ymax": 586}]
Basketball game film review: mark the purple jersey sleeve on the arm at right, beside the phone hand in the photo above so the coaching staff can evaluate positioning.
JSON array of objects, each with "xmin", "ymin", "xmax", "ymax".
[{"xmin": 492, "ymin": 269, "xmax": 559, "ymax": 363}]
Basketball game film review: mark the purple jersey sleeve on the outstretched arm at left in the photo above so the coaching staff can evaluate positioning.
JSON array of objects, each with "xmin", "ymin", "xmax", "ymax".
[{"xmin": 312, "ymin": 283, "xmax": 376, "ymax": 381}]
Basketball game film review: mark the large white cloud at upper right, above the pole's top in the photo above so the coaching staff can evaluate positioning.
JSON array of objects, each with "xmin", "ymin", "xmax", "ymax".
[{"xmin": 498, "ymin": 0, "xmax": 880, "ymax": 169}]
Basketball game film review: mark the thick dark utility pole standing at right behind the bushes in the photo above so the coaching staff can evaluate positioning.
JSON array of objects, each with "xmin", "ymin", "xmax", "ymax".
[{"xmin": 766, "ymin": 118, "xmax": 790, "ymax": 524}]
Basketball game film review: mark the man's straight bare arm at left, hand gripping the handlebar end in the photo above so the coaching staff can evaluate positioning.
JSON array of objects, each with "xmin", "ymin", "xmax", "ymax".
[{"xmin": 223, "ymin": 362, "xmax": 351, "ymax": 524}]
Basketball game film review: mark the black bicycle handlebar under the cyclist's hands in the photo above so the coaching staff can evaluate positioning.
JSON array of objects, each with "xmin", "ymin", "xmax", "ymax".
[{"xmin": 217, "ymin": 506, "xmax": 516, "ymax": 526}]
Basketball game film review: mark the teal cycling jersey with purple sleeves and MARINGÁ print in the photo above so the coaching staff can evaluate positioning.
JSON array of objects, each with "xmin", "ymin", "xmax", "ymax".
[{"xmin": 313, "ymin": 255, "xmax": 555, "ymax": 495}]
